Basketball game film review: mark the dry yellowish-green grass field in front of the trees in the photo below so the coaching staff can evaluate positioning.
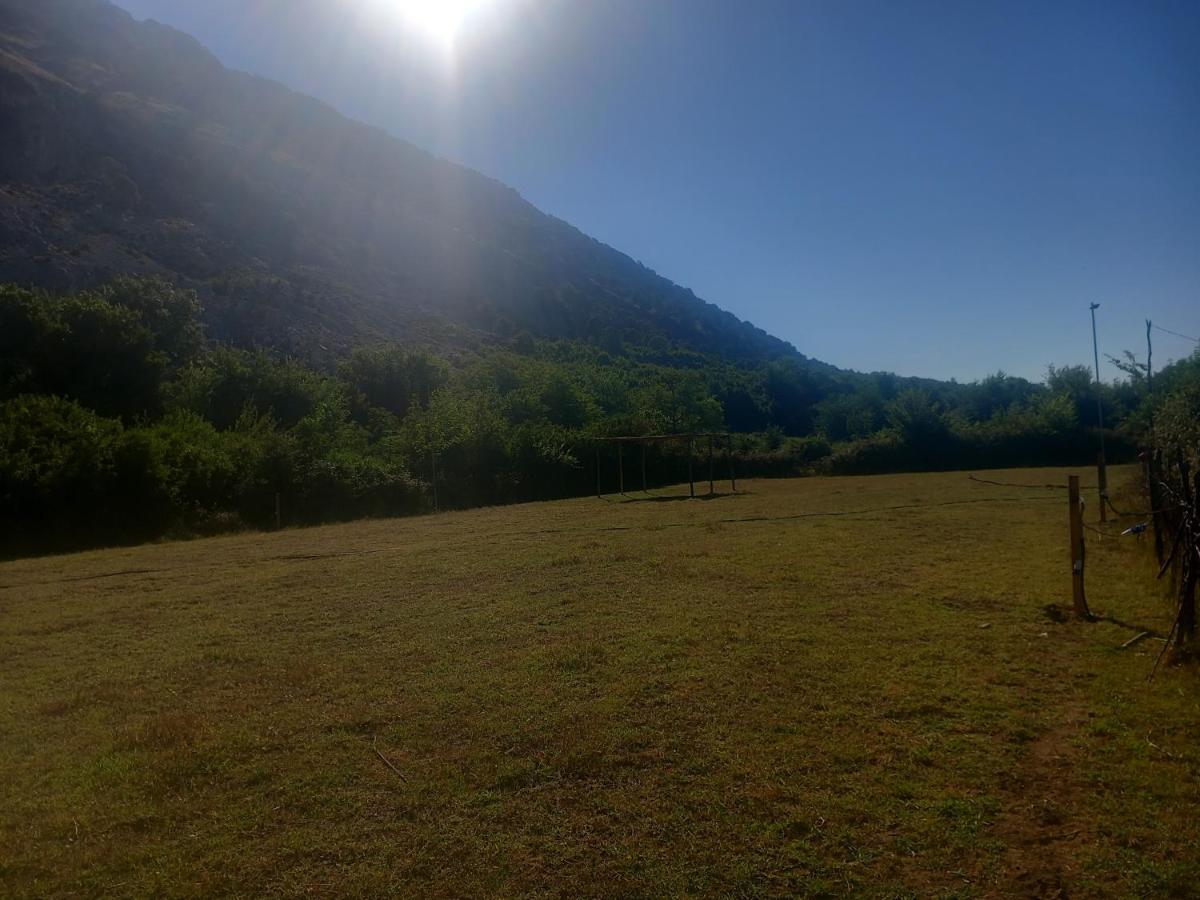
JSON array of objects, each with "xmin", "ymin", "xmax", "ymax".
[{"xmin": 0, "ymin": 470, "xmax": 1200, "ymax": 898}]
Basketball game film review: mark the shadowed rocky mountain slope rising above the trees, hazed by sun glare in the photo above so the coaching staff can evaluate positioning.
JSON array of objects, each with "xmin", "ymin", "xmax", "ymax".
[{"xmin": 0, "ymin": 0, "xmax": 798, "ymax": 360}]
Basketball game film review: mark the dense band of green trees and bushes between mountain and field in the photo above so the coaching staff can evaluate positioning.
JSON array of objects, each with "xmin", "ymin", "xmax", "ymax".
[{"xmin": 0, "ymin": 278, "xmax": 1200, "ymax": 553}]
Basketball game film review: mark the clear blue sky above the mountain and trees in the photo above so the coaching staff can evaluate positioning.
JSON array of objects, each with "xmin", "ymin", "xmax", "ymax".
[{"xmin": 118, "ymin": 0, "xmax": 1200, "ymax": 380}]
